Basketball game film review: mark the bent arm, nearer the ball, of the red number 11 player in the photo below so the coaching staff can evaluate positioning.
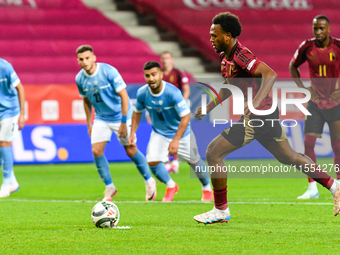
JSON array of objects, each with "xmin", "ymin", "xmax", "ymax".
[{"xmin": 289, "ymin": 41, "xmax": 319, "ymax": 102}]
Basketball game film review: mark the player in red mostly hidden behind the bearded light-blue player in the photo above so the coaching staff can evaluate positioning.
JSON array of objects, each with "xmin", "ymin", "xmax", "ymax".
[{"xmin": 161, "ymin": 51, "xmax": 190, "ymax": 173}]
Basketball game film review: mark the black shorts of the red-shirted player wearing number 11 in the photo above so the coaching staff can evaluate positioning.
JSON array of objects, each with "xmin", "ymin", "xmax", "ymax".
[{"xmin": 304, "ymin": 101, "xmax": 340, "ymax": 137}]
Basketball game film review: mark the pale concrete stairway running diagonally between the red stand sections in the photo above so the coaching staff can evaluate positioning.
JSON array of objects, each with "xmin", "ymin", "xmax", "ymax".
[{"xmin": 82, "ymin": 0, "xmax": 215, "ymax": 78}]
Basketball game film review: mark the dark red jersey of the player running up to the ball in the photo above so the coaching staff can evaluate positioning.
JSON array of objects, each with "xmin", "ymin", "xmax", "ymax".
[{"xmin": 220, "ymin": 41, "xmax": 272, "ymax": 110}]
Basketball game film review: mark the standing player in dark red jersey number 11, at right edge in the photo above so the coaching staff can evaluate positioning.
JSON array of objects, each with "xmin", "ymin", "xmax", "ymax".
[{"xmin": 289, "ymin": 15, "xmax": 340, "ymax": 199}]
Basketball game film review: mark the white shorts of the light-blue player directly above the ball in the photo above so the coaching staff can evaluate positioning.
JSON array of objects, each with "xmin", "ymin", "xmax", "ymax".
[{"xmin": 91, "ymin": 119, "xmax": 131, "ymax": 146}]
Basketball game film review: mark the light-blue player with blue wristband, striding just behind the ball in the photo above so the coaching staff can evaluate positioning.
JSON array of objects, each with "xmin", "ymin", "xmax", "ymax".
[{"xmin": 76, "ymin": 45, "xmax": 156, "ymax": 201}]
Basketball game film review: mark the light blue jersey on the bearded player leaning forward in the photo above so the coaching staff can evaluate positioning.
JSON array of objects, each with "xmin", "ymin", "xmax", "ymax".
[{"xmin": 134, "ymin": 81, "xmax": 190, "ymax": 139}]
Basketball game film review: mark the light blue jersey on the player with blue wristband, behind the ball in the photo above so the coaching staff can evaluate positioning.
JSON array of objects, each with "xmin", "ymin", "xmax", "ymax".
[{"xmin": 76, "ymin": 63, "xmax": 132, "ymax": 123}]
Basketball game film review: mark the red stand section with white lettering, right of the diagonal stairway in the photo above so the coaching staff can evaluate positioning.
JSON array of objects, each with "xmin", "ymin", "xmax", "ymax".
[{"xmin": 128, "ymin": 0, "xmax": 340, "ymax": 78}]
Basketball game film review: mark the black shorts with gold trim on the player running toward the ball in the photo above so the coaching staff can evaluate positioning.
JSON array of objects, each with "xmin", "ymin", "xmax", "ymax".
[{"xmin": 221, "ymin": 108, "xmax": 287, "ymax": 148}]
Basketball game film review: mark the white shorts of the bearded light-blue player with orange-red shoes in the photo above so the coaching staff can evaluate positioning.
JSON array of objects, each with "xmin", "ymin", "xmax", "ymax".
[{"xmin": 146, "ymin": 131, "xmax": 201, "ymax": 164}]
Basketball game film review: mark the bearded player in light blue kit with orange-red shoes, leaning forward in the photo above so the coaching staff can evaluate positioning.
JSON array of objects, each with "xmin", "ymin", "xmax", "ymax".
[{"xmin": 128, "ymin": 61, "xmax": 213, "ymax": 202}]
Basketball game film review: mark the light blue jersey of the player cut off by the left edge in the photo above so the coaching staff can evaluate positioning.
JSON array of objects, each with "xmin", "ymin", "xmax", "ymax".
[{"xmin": 0, "ymin": 58, "xmax": 20, "ymax": 120}]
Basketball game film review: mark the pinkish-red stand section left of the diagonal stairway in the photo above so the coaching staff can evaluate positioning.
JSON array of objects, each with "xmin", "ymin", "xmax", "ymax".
[{"xmin": 0, "ymin": 0, "xmax": 159, "ymax": 84}]
